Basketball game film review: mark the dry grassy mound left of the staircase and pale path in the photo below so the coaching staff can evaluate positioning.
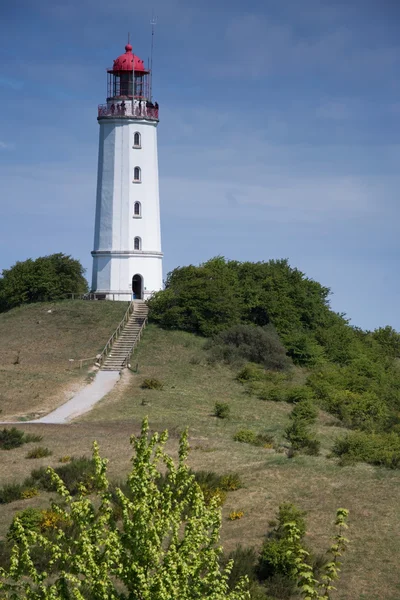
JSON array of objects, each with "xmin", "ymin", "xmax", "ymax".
[{"xmin": 0, "ymin": 300, "xmax": 127, "ymax": 420}]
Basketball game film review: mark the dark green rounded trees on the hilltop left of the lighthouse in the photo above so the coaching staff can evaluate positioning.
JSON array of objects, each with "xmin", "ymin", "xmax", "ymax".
[{"xmin": 0, "ymin": 253, "xmax": 88, "ymax": 312}]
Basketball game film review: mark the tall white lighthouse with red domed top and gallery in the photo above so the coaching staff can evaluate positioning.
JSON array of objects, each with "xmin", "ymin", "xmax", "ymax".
[{"xmin": 92, "ymin": 43, "xmax": 163, "ymax": 300}]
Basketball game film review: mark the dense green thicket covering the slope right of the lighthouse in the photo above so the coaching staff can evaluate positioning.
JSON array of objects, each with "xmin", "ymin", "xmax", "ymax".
[{"xmin": 150, "ymin": 258, "xmax": 400, "ymax": 467}]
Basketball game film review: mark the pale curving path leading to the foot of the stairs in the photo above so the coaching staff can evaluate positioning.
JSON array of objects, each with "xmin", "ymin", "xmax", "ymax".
[{"xmin": 2, "ymin": 371, "xmax": 120, "ymax": 424}]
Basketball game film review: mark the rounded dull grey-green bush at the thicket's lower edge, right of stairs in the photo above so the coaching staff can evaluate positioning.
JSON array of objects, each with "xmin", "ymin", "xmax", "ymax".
[{"xmin": 205, "ymin": 324, "xmax": 290, "ymax": 371}]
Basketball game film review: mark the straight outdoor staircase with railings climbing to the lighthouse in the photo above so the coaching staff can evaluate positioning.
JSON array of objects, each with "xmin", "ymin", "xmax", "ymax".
[{"xmin": 101, "ymin": 301, "xmax": 148, "ymax": 371}]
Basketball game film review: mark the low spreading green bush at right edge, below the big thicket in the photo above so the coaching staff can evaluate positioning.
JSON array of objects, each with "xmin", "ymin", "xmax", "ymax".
[{"xmin": 332, "ymin": 431, "xmax": 400, "ymax": 469}]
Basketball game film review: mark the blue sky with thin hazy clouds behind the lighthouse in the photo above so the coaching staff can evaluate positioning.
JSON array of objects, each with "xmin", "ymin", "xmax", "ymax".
[{"xmin": 0, "ymin": 0, "xmax": 400, "ymax": 329}]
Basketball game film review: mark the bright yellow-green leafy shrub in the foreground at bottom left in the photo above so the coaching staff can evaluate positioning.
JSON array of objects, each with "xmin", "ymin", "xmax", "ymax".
[{"xmin": 0, "ymin": 420, "xmax": 250, "ymax": 600}]
